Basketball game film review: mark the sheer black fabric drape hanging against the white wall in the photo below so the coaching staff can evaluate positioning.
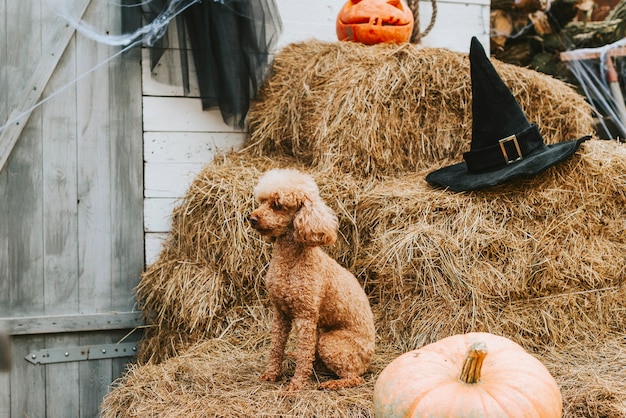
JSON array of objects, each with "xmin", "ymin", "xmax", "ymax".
[{"xmin": 144, "ymin": 0, "xmax": 282, "ymax": 128}]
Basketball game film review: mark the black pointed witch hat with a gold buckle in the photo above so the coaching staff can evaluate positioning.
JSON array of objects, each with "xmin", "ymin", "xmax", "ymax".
[{"xmin": 426, "ymin": 37, "xmax": 591, "ymax": 192}]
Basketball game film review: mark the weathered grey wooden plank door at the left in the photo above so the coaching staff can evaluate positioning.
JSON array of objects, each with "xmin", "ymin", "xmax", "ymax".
[{"xmin": 0, "ymin": 0, "xmax": 143, "ymax": 418}]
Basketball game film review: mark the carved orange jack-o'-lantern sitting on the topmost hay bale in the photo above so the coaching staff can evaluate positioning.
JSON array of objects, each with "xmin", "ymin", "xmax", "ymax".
[{"xmin": 336, "ymin": 0, "xmax": 413, "ymax": 45}]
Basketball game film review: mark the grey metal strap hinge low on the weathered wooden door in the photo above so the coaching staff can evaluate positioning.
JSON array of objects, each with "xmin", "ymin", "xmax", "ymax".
[{"xmin": 24, "ymin": 343, "xmax": 137, "ymax": 364}]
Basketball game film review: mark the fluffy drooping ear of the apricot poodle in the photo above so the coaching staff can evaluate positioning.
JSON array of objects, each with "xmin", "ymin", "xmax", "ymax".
[{"xmin": 293, "ymin": 199, "xmax": 337, "ymax": 246}]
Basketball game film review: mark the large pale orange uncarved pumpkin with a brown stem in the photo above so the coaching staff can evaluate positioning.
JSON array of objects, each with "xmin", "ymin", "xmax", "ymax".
[{"xmin": 374, "ymin": 333, "xmax": 563, "ymax": 418}]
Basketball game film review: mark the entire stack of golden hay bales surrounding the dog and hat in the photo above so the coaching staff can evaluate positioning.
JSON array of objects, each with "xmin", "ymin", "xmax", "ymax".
[{"xmin": 102, "ymin": 42, "xmax": 626, "ymax": 417}]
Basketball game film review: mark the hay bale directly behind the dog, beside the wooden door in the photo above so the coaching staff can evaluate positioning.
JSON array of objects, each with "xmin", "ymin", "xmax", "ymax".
[{"xmin": 136, "ymin": 153, "xmax": 362, "ymax": 363}]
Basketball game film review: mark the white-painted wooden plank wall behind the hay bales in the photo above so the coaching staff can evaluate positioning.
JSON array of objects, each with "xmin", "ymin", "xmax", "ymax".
[{"xmin": 143, "ymin": 0, "xmax": 490, "ymax": 264}]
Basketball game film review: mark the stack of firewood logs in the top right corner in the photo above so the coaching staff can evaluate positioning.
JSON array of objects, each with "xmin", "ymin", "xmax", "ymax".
[{"xmin": 491, "ymin": 0, "xmax": 626, "ymax": 84}]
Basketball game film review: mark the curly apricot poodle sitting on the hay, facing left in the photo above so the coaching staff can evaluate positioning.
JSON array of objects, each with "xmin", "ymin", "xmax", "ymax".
[{"xmin": 250, "ymin": 169, "xmax": 375, "ymax": 391}]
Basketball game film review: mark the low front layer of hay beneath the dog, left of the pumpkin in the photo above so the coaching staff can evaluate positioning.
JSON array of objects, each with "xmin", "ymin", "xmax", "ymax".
[{"xmin": 101, "ymin": 340, "xmax": 384, "ymax": 418}]
